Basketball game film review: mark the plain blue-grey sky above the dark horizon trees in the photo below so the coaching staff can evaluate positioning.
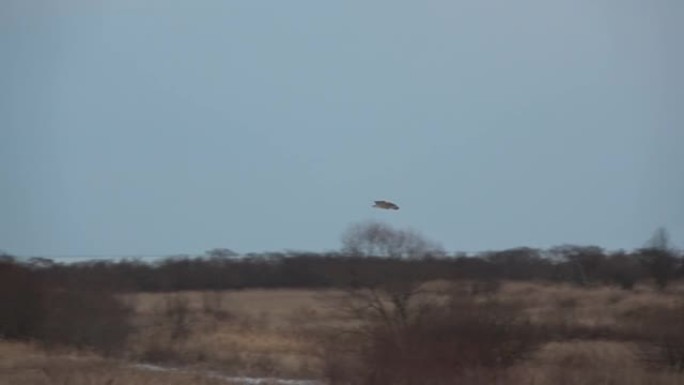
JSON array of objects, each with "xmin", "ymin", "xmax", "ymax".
[{"xmin": 0, "ymin": 0, "xmax": 684, "ymax": 256}]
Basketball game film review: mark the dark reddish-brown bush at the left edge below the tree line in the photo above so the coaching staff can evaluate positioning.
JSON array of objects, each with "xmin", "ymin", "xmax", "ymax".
[{"xmin": 0, "ymin": 262, "xmax": 131, "ymax": 354}]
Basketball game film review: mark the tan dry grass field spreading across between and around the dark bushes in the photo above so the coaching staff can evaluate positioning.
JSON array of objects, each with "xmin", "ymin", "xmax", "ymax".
[{"xmin": 0, "ymin": 282, "xmax": 684, "ymax": 385}]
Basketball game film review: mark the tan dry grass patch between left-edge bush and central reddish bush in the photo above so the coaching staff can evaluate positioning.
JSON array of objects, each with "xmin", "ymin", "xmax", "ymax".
[{"xmin": 126, "ymin": 289, "xmax": 333, "ymax": 378}]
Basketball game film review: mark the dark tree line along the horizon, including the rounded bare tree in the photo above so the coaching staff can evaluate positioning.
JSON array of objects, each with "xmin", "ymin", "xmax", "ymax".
[{"xmin": 0, "ymin": 222, "xmax": 684, "ymax": 292}]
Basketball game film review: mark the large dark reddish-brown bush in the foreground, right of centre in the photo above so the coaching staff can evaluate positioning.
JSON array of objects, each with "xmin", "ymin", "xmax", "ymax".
[{"xmin": 325, "ymin": 284, "xmax": 541, "ymax": 385}]
